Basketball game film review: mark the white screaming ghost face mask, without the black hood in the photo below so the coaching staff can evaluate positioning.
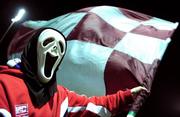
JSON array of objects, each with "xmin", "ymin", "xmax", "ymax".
[{"xmin": 37, "ymin": 29, "xmax": 66, "ymax": 83}]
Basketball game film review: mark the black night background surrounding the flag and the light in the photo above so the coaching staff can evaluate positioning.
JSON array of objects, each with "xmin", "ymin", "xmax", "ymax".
[{"xmin": 0, "ymin": 0, "xmax": 180, "ymax": 117}]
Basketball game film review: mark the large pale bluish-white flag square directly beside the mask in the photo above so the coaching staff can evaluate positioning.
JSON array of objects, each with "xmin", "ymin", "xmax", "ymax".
[{"xmin": 57, "ymin": 40, "xmax": 112, "ymax": 96}]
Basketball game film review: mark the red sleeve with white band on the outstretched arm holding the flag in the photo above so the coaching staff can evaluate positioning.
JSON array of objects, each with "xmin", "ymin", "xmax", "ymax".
[{"xmin": 64, "ymin": 90, "xmax": 133, "ymax": 117}]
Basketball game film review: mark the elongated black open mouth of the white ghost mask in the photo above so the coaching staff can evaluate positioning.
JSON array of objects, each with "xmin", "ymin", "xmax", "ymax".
[{"xmin": 44, "ymin": 53, "xmax": 58, "ymax": 77}]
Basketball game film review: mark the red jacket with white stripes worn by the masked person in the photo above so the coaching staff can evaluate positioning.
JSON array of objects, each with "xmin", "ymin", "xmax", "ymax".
[{"xmin": 0, "ymin": 66, "xmax": 133, "ymax": 117}]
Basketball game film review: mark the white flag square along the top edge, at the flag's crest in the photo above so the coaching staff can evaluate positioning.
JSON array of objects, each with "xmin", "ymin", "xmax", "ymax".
[{"xmin": 90, "ymin": 6, "xmax": 140, "ymax": 32}]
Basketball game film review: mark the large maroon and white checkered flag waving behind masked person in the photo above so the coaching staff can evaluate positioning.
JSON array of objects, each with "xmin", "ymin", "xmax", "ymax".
[{"xmin": 8, "ymin": 6, "xmax": 178, "ymax": 116}]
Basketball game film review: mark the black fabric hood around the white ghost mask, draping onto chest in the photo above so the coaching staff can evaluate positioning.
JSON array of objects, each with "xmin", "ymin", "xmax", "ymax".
[{"xmin": 21, "ymin": 28, "xmax": 63, "ymax": 107}]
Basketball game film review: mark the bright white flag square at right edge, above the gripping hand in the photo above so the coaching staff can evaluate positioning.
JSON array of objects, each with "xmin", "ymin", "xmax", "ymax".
[{"xmin": 115, "ymin": 33, "xmax": 170, "ymax": 64}]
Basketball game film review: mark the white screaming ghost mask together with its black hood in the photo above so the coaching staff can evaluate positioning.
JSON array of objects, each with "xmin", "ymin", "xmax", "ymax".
[{"xmin": 20, "ymin": 28, "xmax": 66, "ymax": 107}]
